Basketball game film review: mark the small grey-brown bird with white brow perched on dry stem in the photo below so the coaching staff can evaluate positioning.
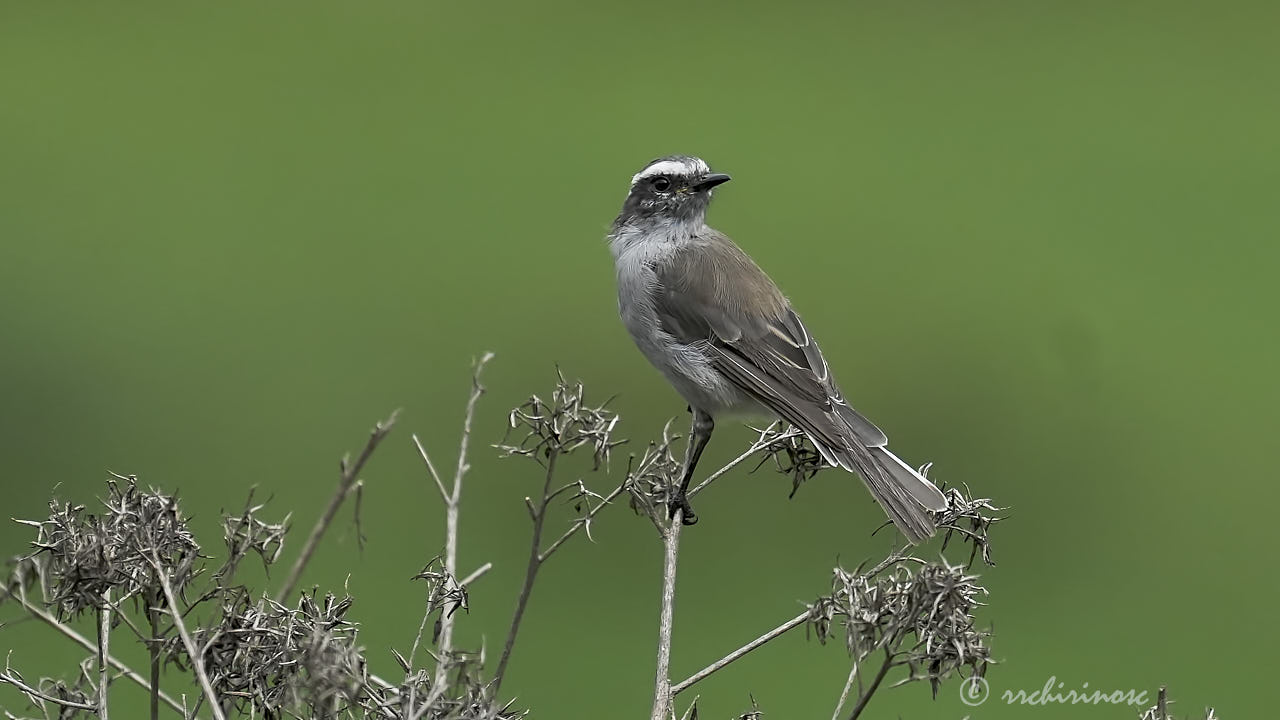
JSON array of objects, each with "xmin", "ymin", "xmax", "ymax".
[{"xmin": 607, "ymin": 155, "xmax": 947, "ymax": 543}]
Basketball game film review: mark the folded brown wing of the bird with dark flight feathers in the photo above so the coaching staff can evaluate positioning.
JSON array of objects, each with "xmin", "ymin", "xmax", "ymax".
[{"xmin": 653, "ymin": 231, "xmax": 887, "ymax": 448}]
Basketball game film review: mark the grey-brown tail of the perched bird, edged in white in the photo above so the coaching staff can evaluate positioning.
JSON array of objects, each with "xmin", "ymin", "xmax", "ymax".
[{"xmin": 819, "ymin": 442, "xmax": 947, "ymax": 543}]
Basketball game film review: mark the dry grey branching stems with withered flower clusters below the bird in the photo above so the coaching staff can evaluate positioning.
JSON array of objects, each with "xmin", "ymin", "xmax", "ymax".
[{"xmin": 0, "ymin": 355, "xmax": 1208, "ymax": 720}]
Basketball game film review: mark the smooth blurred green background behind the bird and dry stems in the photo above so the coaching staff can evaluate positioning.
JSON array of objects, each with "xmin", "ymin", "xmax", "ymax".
[{"xmin": 0, "ymin": 0, "xmax": 1280, "ymax": 720}]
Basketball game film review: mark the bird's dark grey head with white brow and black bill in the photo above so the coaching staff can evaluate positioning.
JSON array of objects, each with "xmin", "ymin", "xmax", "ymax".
[{"xmin": 618, "ymin": 155, "xmax": 728, "ymax": 223}]
